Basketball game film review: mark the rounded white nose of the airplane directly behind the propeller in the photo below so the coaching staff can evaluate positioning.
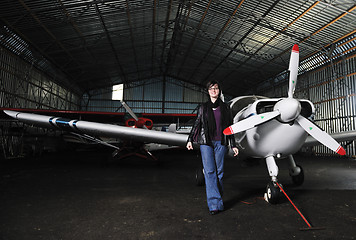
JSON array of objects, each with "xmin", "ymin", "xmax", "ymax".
[{"xmin": 231, "ymin": 96, "xmax": 314, "ymax": 158}]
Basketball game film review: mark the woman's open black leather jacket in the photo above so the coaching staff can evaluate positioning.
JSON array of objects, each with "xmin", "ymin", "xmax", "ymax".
[{"xmin": 188, "ymin": 100, "xmax": 236, "ymax": 147}]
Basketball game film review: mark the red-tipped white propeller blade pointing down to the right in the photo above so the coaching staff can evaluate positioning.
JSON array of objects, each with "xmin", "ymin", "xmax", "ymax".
[{"xmin": 296, "ymin": 116, "xmax": 346, "ymax": 155}]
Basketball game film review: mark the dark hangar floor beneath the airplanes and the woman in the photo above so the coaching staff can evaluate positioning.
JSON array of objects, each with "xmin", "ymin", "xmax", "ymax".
[{"xmin": 0, "ymin": 150, "xmax": 356, "ymax": 240}]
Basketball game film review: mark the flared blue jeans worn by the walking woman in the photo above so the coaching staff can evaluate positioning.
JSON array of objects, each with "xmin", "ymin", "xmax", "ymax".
[{"xmin": 200, "ymin": 141, "xmax": 227, "ymax": 211}]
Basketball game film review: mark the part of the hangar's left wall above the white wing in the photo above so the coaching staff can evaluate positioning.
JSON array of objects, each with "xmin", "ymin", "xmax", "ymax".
[{"xmin": 0, "ymin": 47, "xmax": 80, "ymax": 110}]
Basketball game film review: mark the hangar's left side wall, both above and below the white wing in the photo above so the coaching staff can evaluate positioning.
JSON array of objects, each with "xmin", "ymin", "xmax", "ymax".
[{"xmin": 0, "ymin": 47, "xmax": 80, "ymax": 158}]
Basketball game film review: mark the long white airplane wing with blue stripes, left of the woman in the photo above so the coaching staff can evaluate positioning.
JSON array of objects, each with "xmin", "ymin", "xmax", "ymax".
[{"xmin": 4, "ymin": 110, "xmax": 188, "ymax": 146}]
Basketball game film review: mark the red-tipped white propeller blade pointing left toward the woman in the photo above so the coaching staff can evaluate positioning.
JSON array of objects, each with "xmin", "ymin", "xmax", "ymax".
[{"xmin": 224, "ymin": 111, "xmax": 280, "ymax": 135}]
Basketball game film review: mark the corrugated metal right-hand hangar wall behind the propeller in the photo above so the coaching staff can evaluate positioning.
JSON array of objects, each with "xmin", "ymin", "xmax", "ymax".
[{"xmin": 262, "ymin": 44, "xmax": 356, "ymax": 156}]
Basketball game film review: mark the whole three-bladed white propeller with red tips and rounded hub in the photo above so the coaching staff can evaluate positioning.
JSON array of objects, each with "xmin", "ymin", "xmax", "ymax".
[{"xmin": 224, "ymin": 44, "xmax": 346, "ymax": 155}]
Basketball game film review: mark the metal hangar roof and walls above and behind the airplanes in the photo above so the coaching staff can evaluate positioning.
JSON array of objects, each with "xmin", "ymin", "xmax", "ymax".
[{"xmin": 0, "ymin": 0, "xmax": 356, "ymax": 158}]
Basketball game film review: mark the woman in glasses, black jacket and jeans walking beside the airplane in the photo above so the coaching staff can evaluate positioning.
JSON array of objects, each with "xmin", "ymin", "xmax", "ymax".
[{"xmin": 187, "ymin": 81, "xmax": 239, "ymax": 215}]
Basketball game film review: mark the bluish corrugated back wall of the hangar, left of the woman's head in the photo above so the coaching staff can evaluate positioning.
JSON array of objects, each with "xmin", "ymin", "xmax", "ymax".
[{"xmin": 82, "ymin": 77, "xmax": 207, "ymax": 114}]
